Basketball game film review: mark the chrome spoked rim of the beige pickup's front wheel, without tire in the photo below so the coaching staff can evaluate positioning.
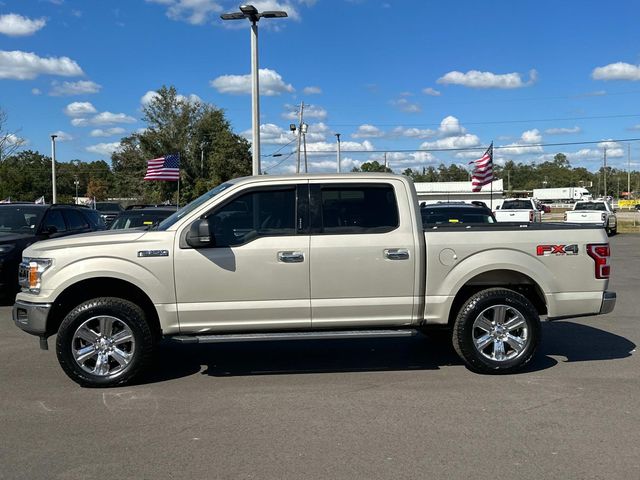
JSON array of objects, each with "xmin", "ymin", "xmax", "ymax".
[{"xmin": 71, "ymin": 315, "xmax": 136, "ymax": 377}]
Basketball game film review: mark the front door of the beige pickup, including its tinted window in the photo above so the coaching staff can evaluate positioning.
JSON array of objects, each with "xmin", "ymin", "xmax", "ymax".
[{"xmin": 174, "ymin": 181, "xmax": 311, "ymax": 333}]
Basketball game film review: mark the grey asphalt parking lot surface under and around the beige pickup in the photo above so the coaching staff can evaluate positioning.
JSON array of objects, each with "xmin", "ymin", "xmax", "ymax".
[{"xmin": 0, "ymin": 234, "xmax": 640, "ymax": 480}]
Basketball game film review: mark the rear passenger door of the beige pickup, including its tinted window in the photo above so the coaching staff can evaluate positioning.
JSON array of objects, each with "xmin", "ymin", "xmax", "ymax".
[{"xmin": 310, "ymin": 180, "xmax": 418, "ymax": 328}]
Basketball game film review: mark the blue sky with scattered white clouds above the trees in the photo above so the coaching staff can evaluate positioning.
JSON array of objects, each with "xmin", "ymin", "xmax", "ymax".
[{"xmin": 0, "ymin": 0, "xmax": 640, "ymax": 173}]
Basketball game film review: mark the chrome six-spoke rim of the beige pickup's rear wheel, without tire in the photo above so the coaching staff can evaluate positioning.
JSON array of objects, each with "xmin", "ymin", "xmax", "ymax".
[{"xmin": 472, "ymin": 305, "xmax": 530, "ymax": 362}]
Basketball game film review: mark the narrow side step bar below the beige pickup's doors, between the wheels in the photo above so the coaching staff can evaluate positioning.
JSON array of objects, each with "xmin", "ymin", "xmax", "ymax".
[{"xmin": 171, "ymin": 329, "xmax": 418, "ymax": 343}]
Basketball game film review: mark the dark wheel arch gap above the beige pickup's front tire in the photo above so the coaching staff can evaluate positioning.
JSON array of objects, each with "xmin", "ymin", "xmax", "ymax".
[{"xmin": 47, "ymin": 277, "xmax": 162, "ymax": 340}]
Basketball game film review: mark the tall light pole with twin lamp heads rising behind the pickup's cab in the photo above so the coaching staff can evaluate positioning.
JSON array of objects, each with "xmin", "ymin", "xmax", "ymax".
[{"xmin": 220, "ymin": 5, "xmax": 287, "ymax": 175}]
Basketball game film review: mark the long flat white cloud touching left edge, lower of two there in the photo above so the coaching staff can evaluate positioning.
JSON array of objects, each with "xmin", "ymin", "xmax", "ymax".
[{"xmin": 0, "ymin": 50, "xmax": 84, "ymax": 80}]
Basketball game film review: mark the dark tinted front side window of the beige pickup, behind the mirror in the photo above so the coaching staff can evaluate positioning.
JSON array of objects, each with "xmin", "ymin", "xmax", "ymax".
[{"xmin": 207, "ymin": 187, "xmax": 296, "ymax": 247}]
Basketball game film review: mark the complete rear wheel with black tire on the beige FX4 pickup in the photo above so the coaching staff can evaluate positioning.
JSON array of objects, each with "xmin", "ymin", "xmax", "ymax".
[{"xmin": 453, "ymin": 288, "xmax": 541, "ymax": 374}]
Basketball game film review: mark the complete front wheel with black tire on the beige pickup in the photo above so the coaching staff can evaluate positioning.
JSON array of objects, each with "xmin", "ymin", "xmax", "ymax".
[{"xmin": 56, "ymin": 297, "xmax": 155, "ymax": 387}]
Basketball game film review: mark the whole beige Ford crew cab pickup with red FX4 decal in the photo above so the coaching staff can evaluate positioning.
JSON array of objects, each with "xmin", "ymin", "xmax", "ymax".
[{"xmin": 13, "ymin": 173, "xmax": 616, "ymax": 386}]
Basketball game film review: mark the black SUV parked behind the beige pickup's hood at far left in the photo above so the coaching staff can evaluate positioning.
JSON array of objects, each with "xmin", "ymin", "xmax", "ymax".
[{"xmin": 0, "ymin": 203, "xmax": 106, "ymax": 299}]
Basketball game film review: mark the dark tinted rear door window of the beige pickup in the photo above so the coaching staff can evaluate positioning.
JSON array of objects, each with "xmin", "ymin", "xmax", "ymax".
[{"xmin": 321, "ymin": 185, "xmax": 399, "ymax": 234}]
